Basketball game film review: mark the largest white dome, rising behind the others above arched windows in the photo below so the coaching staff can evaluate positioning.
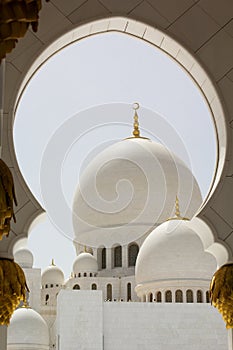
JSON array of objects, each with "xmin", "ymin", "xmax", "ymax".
[{"xmin": 73, "ymin": 138, "xmax": 202, "ymax": 247}]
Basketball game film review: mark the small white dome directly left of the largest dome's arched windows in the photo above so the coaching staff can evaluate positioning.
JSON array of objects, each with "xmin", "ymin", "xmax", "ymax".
[{"xmin": 73, "ymin": 252, "xmax": 98, "ymax": 275}]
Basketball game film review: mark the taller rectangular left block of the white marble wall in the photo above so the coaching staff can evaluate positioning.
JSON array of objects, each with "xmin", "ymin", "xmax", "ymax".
[{"xmin": 57, "ymin": 290, "xmax": 103, "ymax": 350}]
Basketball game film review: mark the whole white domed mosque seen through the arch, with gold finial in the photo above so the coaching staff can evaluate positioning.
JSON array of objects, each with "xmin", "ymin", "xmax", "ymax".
[{"xmin": 8, "ymin": 104, "xmax": 227, "ymax": 350}]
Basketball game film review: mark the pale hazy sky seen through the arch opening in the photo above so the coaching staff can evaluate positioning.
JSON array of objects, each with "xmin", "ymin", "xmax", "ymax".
[{"xmin": 14, "ymin": 33, "xmax": 216, "ymax": 277}]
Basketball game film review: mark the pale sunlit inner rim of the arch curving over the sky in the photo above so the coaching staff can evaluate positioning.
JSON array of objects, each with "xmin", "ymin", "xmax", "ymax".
[{"xmin": 10, "ymin": 17, "xmax": 226, "ymax": 274}]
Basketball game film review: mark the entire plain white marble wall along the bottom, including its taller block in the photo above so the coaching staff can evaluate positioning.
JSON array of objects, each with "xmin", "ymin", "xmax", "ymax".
[{"xmin": 57, "ymin": 290, "xmax": 228, "ymax": 350}]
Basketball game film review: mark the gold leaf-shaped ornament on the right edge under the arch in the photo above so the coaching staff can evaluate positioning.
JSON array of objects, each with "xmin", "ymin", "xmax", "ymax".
[{"xmin": 210, "ymin": 263, "xmax": 233, "ymax": 328}]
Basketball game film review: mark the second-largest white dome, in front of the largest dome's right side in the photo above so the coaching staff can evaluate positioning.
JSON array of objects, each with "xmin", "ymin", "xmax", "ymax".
[{"xmin": 135, "ymin": 220, "xmax": 216, "ymax": 285}]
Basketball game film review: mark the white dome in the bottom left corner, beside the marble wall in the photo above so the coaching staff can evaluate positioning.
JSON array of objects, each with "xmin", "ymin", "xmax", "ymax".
[{"xmin": 7, "ymin": 308, "xmax": 49, "ymax": 350}]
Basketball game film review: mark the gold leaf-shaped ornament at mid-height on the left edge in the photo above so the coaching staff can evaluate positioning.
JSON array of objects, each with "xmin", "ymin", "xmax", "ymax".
[{"xmin": 0, "ymin": 159, "xmax": 17, "ymax": 240}]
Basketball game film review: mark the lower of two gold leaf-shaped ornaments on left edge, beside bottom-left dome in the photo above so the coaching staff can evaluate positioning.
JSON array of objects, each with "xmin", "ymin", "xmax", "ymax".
[{"xmin": 0, "ymin": 258, "xmax": 29, "ymax": 325}]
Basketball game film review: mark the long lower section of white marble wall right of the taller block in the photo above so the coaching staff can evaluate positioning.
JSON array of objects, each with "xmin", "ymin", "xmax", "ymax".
[{"xmin": 104, "ymin": 303, "xmax": 227, "ymax": 350}]
